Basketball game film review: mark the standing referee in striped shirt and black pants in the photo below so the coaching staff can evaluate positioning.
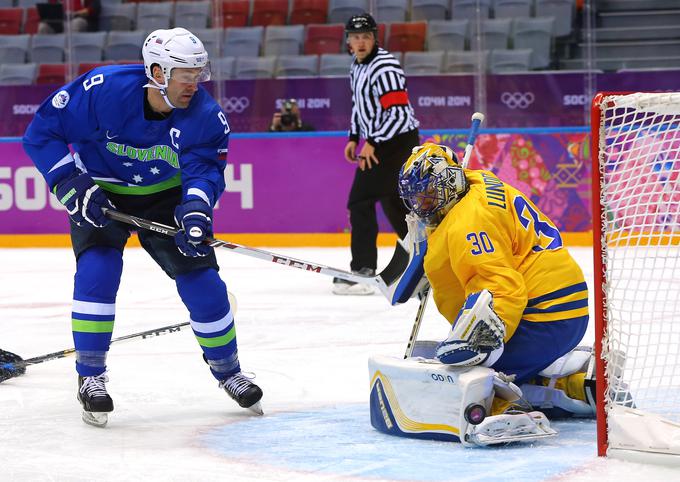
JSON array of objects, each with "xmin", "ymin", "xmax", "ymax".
[{"xmin": 333, "ymin": 13, "xmax": 420, "ymax": 295}]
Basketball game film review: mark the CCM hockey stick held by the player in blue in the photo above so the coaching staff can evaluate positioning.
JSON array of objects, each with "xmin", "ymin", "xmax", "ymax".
[{"xmin": 104, "ymin": 209, "xmax": 415, "ymax": 304}]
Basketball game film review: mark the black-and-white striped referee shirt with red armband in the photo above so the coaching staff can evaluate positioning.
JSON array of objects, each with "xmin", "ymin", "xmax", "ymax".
[{"xmin": 349, "ymin": 48, "xmax": 418, "ymax": 146}]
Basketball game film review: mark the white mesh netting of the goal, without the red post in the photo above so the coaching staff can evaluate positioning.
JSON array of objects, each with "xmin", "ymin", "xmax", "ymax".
[{"xmin": 598, "ymin": 94, "xmax": 680, "ymax": 423}]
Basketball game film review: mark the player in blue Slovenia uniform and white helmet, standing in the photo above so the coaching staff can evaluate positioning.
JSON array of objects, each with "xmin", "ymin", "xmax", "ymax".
[{"xmin": 23, "ymin": 28, "xmax": 262, "ymax": 425}]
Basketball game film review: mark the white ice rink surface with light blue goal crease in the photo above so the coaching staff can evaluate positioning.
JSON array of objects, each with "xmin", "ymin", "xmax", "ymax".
[{"xmin": 0, "ymin": 248, "xmax": 680, "ymax": 482}]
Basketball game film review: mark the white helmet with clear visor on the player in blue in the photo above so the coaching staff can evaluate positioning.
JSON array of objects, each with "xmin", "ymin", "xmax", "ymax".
[{"xmin": 142, "ymin": 27, "xmax": 210, "ymax": 88}]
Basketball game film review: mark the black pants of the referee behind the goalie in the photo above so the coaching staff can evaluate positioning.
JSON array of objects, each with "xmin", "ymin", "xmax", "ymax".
[{"xmin": 347, "ymin": 129, "xmax": 420, "ymax": 271}]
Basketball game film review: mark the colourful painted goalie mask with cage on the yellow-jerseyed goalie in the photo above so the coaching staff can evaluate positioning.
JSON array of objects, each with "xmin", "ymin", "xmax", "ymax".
[{"xmin": 399, "ymin": 142, "xmax": 468, "ymax": 225}]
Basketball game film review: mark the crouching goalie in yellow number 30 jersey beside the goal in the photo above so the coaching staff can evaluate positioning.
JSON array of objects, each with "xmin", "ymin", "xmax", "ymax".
[{"xmin": 399, "ymin": 143, "xmax": 595, "ymax": 430}]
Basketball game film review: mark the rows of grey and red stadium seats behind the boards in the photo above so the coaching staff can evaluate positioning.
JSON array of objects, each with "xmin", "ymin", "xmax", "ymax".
[{"xmin": 0, "ymin": 0, "xmax": 680, "ymax": 82}]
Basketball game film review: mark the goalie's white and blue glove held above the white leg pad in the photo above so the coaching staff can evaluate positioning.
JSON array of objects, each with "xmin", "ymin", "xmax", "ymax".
[{"xmin": 435, "ymin": 290, "xmax": 505, "ymax": 367}]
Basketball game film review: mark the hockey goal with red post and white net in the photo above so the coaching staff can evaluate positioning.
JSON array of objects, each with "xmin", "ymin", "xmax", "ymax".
[{"xmin": 591, "ymin": 93, "xmax": 680, "ymax": 465}]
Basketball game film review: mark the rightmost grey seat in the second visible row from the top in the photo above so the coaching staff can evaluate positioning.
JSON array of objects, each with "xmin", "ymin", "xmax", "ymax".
[{"xmin": 512, "ymin": 17, "xmax": 555, "ymax": 69}]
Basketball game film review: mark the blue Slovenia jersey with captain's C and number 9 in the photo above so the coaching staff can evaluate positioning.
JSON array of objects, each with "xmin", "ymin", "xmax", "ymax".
[{"xmin": 23, "ymin": 65, "xmax": 229, "ymax": 206}]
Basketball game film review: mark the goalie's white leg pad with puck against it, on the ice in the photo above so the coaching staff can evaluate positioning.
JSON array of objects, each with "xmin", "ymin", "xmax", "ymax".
[{"xmin": 368, "ymin": 356, "xmax": 557, "ymax": 447}]
